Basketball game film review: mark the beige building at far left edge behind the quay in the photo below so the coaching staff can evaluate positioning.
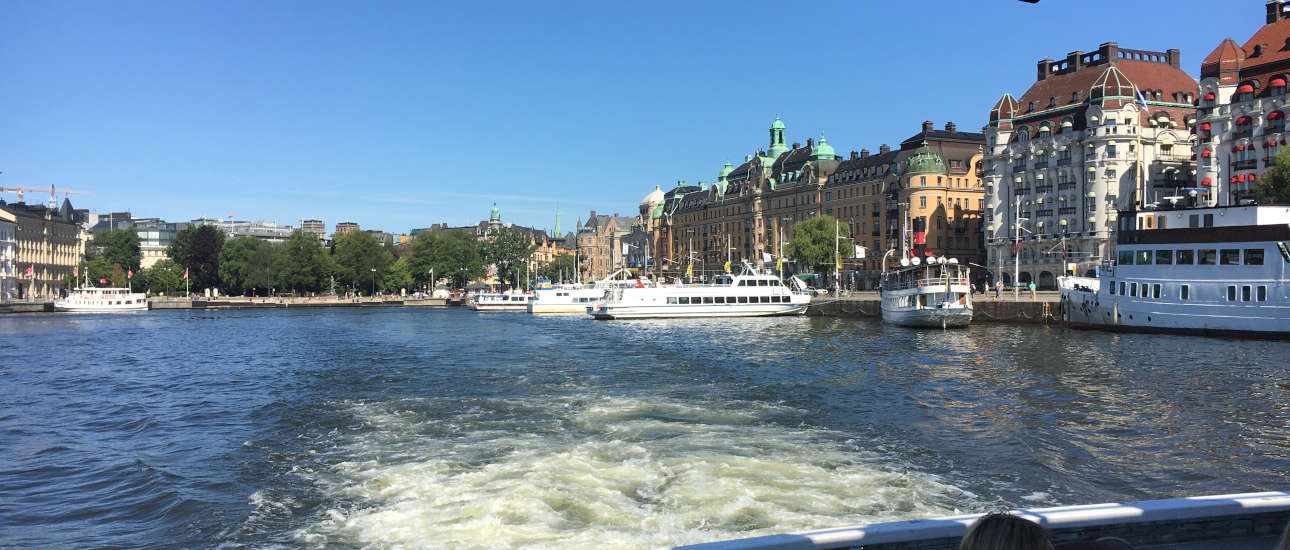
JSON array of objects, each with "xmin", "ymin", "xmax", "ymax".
[{"xmin": 0, "ymin": 199, "xmax": 88, "ymax": 297}]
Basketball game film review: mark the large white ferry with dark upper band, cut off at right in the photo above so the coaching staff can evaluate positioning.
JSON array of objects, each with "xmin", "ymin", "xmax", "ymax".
[{"xmin": 1058, "ymin": 205, "xmax": 1290, "ymax": 338}]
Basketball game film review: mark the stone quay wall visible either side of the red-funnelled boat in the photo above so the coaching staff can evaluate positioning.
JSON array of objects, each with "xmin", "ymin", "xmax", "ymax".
[{"xmin": 806, "ymin": 290, "xmax": 1060, "ymax": 324}]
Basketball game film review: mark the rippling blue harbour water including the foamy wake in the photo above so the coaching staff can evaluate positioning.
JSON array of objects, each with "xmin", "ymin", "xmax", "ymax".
[{"xmin": 0, "ymin": 309, "xmax": 1290, "ymax": 549}]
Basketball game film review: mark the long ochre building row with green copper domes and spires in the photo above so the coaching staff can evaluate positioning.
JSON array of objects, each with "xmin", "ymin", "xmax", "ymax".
[{"xmin": 641, "ymin": 117, "xmax": 984, "ymax": 288}]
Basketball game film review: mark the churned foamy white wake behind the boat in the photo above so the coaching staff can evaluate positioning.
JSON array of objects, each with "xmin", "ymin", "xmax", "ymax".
[{"xmin": 297, "ymin": 396, "xmax": 973, "ymax": 549}]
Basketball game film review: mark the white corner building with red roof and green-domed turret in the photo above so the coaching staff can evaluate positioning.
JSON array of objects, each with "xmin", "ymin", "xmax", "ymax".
[{"xmin": 984, "ymin": 43, "xmax": 1197, "ymax": 289}]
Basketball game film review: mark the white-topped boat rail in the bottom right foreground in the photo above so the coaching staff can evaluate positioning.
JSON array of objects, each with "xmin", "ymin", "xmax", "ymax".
[{"xmin": 679, "ymin": 491, "xmax": 1290, "ymax": 550}]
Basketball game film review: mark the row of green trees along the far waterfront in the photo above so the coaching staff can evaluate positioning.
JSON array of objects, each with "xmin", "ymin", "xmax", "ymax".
[{"xmin": 71, "ymin": 226, "xmax": 574, "ymax": 296}]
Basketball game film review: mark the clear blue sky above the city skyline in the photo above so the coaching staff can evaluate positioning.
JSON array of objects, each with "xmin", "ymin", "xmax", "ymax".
[{"xmin": 0, "ymin": 0, "xmax": 1264, "ymax": 232}]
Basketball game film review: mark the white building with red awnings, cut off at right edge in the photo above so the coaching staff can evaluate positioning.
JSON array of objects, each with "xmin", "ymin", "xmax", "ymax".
[{"xmin": 1196, "ymin": 0, "xmax": 1290, "ymax": 205}]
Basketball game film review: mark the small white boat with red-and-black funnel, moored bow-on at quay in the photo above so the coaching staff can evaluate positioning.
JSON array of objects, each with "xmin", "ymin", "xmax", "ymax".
[{"xmin": 881, "ymin": 256, "xmax": 973, "ymax": 328}]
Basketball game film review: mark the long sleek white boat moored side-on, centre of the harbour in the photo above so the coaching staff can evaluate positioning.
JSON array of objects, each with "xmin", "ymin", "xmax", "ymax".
[{"xmin": 587, "ymin": 263, "xmax": 810, "ymax": 320}]
